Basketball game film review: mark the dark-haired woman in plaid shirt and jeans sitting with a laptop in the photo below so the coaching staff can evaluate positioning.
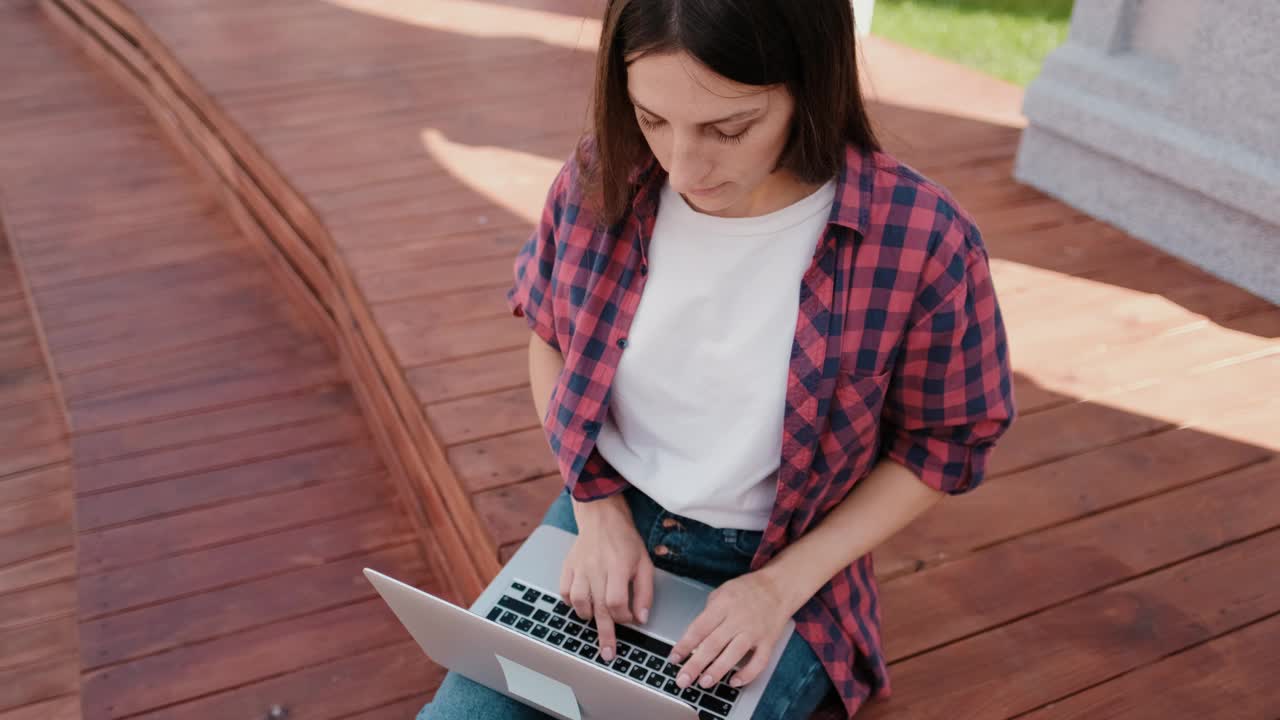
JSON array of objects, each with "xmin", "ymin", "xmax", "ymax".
[{"xmin": 421, "ymin": 0, "xmax": 1014, "ymax": 719}]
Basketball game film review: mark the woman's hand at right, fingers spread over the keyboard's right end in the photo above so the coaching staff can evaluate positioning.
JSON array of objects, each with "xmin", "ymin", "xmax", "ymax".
[{"xmin": 671, "ymin": 571, "xmax": 791, "ymax": 688}]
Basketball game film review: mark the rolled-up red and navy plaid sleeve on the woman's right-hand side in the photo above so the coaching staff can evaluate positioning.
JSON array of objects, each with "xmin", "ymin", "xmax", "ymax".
[{"xmin": 882, "ymin": 229, "xmax": 1015, "ymax": 495}]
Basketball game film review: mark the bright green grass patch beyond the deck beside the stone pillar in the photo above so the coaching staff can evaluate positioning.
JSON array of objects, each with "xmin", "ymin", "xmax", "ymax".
[{"xmin": 872, "ymin": 0, "xmax": 1071, "ymax": 86}]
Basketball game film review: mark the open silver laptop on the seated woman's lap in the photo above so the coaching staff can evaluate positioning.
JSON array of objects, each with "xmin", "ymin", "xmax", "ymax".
[{"xmin": 365, "ymin": 517, "xmax": 795, "ymax": 720}]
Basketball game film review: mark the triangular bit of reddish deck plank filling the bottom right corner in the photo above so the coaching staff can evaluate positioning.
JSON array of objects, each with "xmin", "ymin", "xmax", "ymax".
[{"xmin": 1025, "ymin": 607, "xmax": 1280, "ymax": 720}]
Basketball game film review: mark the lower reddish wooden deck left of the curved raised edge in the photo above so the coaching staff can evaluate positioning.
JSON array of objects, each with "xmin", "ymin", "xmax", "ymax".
[{"xmin": 0, "ymin": 3, "xmax": 451, "ymax": 720}]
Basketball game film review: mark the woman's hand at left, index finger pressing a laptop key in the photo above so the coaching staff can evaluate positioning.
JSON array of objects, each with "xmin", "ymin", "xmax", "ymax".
[{"xmin": 559, "ymin": 495, "xmax": 653, "ymax": 660}]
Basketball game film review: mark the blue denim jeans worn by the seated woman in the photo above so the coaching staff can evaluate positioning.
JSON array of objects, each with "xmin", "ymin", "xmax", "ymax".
[{"xmin": 417, "ymin": 487, "xmax": 833, "ymax": 720}]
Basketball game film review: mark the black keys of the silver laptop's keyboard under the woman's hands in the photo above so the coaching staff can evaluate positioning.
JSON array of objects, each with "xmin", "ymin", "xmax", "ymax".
[{"xmin": 486, "ymin": 580, "xmax": 741, "ymax": 720}]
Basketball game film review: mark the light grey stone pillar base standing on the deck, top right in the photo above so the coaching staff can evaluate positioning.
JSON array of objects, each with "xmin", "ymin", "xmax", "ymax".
[{"xmin": 1015, "ymin": 0, "xmax": 1280, "ymax": 302}]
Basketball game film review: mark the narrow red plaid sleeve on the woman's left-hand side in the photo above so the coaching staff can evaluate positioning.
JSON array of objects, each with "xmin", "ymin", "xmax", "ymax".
[{"xmin": 507, "ymin": 160, "xmax": 572, "ymax": 350}]
